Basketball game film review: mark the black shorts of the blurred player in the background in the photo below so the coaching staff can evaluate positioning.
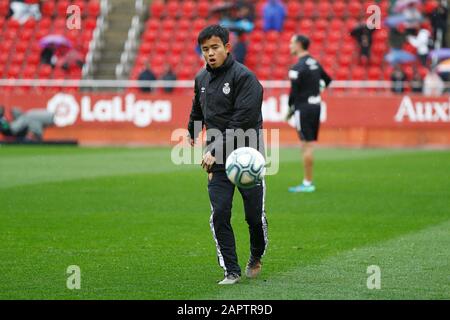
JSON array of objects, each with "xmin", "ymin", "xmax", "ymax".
[{"xmin": 294, "ymin": 105, "xmax": 320, "ymax": 142}]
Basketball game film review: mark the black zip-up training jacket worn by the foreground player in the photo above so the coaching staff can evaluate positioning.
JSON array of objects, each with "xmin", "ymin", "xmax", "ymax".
[{"xmin": 188, "ymin": 55, "xmax": 264, "ymax": 171}]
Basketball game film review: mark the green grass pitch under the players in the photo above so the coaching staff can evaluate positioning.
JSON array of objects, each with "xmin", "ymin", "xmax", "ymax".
[{"xmin": 0, "ymin": 147, "xmax": 450, "ymax": 299}]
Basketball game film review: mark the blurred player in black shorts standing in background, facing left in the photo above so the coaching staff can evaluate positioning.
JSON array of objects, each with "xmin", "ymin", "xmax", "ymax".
[{"xmin": 287, "ymin": 35, "xmax": 331, "ymax": 192}]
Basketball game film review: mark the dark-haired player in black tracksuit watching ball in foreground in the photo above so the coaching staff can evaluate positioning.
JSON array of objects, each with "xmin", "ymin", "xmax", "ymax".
[{"xmin": 188, "ymin": 25, "xmax": 268, "ymax": 284}]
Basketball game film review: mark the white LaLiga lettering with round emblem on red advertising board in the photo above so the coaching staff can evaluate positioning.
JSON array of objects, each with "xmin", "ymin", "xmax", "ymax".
[{"xmin": 47, "ymin": 93, "xmax": 172, "ymax": 128}]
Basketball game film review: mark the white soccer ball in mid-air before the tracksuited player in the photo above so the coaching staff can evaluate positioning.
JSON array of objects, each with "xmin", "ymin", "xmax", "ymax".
[{"xmin": 225, "ymin": 147, "xmax": 266, "ymax": 189}]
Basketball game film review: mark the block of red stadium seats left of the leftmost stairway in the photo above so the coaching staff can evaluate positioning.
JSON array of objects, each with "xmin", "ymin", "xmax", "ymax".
[{"xmin": 0, "ymin": 0, "xmax": 100, "ymax": 89}]
